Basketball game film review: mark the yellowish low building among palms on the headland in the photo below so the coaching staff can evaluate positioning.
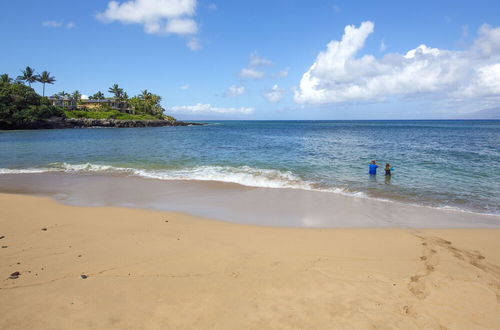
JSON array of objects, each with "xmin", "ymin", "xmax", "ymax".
[{"xmin": 49, "ymin": 96, "xmax": 135, "ymax": 114}]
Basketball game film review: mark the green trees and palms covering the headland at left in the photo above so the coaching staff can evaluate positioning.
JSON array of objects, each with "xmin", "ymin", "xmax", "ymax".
[{"xmin": 0, "ymin": 66, "xmax": 175, "ymax": 128}]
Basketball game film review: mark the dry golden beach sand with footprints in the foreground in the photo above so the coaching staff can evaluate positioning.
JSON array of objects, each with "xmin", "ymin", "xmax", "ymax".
[{"xmin": 0, "ymin": 194, "xmax": 500, "ymax": 329}]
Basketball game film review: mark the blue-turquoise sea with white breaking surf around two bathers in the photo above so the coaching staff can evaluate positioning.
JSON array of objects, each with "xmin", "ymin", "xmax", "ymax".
[{"xmin": 0, "ymin": 121, "xmax": 500, "ymax": 214}]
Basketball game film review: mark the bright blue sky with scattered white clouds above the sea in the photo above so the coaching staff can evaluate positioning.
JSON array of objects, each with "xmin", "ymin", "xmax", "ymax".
[{"xmin": 0, "ymin": 0, "xmax": 500, "ymax": 120}]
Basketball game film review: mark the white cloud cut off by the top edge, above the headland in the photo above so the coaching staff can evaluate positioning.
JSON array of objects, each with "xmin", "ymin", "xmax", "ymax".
[{"xmin": 97, "ymin": 0, "xmax": 198, "ymax": 35}]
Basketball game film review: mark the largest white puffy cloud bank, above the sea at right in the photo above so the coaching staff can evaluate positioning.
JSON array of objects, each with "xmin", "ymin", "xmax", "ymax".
[{"xmin": 294, "ymin": 22, "xmax": 500, "ymax": 104}]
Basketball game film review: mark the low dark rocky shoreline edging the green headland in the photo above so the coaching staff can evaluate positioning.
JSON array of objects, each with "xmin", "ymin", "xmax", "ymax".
[{"xmin": 0, "ymin": 117, "xmax": 203, "ymax": 130}]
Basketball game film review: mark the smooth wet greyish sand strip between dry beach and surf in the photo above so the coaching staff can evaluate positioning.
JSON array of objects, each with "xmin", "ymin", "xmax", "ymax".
[{"xmin": 0, "ymin": 173, "xmax": 500, "ymax": 228}]
